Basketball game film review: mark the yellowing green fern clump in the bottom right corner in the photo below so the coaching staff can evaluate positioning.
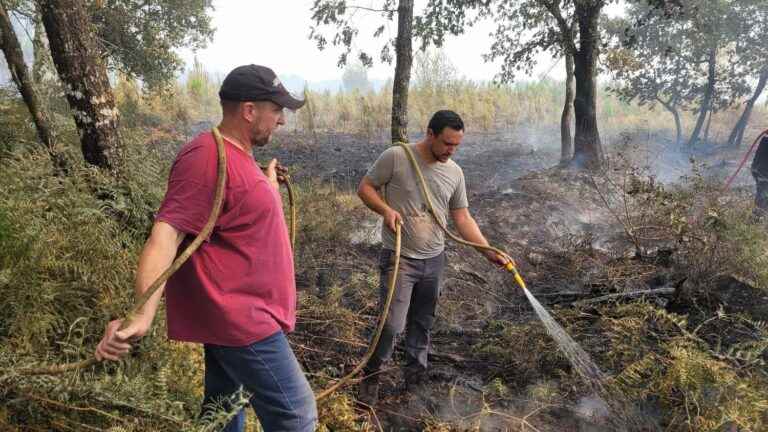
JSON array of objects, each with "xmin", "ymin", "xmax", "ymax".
[{"xmin": 602, "ymin": 303, "xmax": 768, "ymax": 432}]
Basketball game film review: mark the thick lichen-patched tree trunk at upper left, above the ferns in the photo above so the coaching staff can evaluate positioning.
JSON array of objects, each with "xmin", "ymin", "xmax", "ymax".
[{"xmin": 39, "ymin": 0, "xmax": 121, "ymax": 171}]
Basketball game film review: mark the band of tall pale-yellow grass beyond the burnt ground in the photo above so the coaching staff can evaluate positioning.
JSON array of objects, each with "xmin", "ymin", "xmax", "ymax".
[{"xmin": 103, "ymin": 58, "xmax": 768, "ymax": 150}]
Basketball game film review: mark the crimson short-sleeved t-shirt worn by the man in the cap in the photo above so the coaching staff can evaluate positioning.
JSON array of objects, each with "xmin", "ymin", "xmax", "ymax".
[{"xmin": 156, "ymin": 132, "xmax": 296, "ymax": 346}]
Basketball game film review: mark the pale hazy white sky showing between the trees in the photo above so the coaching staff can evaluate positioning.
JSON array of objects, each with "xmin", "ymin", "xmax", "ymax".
[{"xmin": 182, "ymin": 0, "xmax": 615, "ymax": 86}]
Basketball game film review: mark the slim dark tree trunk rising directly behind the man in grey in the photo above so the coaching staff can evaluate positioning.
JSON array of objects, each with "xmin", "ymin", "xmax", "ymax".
[{"xmin": 392, "ymin": 0, "xmax": 413, "ymax": 143}]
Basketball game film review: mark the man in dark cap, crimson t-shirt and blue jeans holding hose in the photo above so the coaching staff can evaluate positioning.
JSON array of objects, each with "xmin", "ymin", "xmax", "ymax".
[{"xmin": 95, "ymin": 65, "xmax": 317, "ymax": 431}]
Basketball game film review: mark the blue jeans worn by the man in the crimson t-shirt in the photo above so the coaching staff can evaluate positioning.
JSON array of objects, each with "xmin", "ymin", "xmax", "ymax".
[{"xmin": 203, "ymin": 331, "xmax": 317, "ymax": 432}]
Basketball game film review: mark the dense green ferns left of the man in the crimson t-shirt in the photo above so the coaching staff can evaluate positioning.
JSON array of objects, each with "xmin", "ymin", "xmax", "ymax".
[{"xmin": 0, "ymin": 137, "xmax": 202, "ymax": 431}]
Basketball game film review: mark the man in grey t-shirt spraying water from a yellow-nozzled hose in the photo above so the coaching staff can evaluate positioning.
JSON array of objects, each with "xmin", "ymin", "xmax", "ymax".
[{"xmin": 357, "ymin": 110, "xmax": 506, "ymax": 405}]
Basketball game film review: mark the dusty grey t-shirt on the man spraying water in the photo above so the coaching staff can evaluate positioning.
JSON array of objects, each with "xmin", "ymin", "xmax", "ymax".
[{"xmin": 366, "ymin": 144, "xmax": 469, "ymax": 259}]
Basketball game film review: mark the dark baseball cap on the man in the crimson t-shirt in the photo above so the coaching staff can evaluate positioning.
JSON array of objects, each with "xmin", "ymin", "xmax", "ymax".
[{"xmin": 219, "ymin": 65, "xmax": 304, "ymax": 111}]
